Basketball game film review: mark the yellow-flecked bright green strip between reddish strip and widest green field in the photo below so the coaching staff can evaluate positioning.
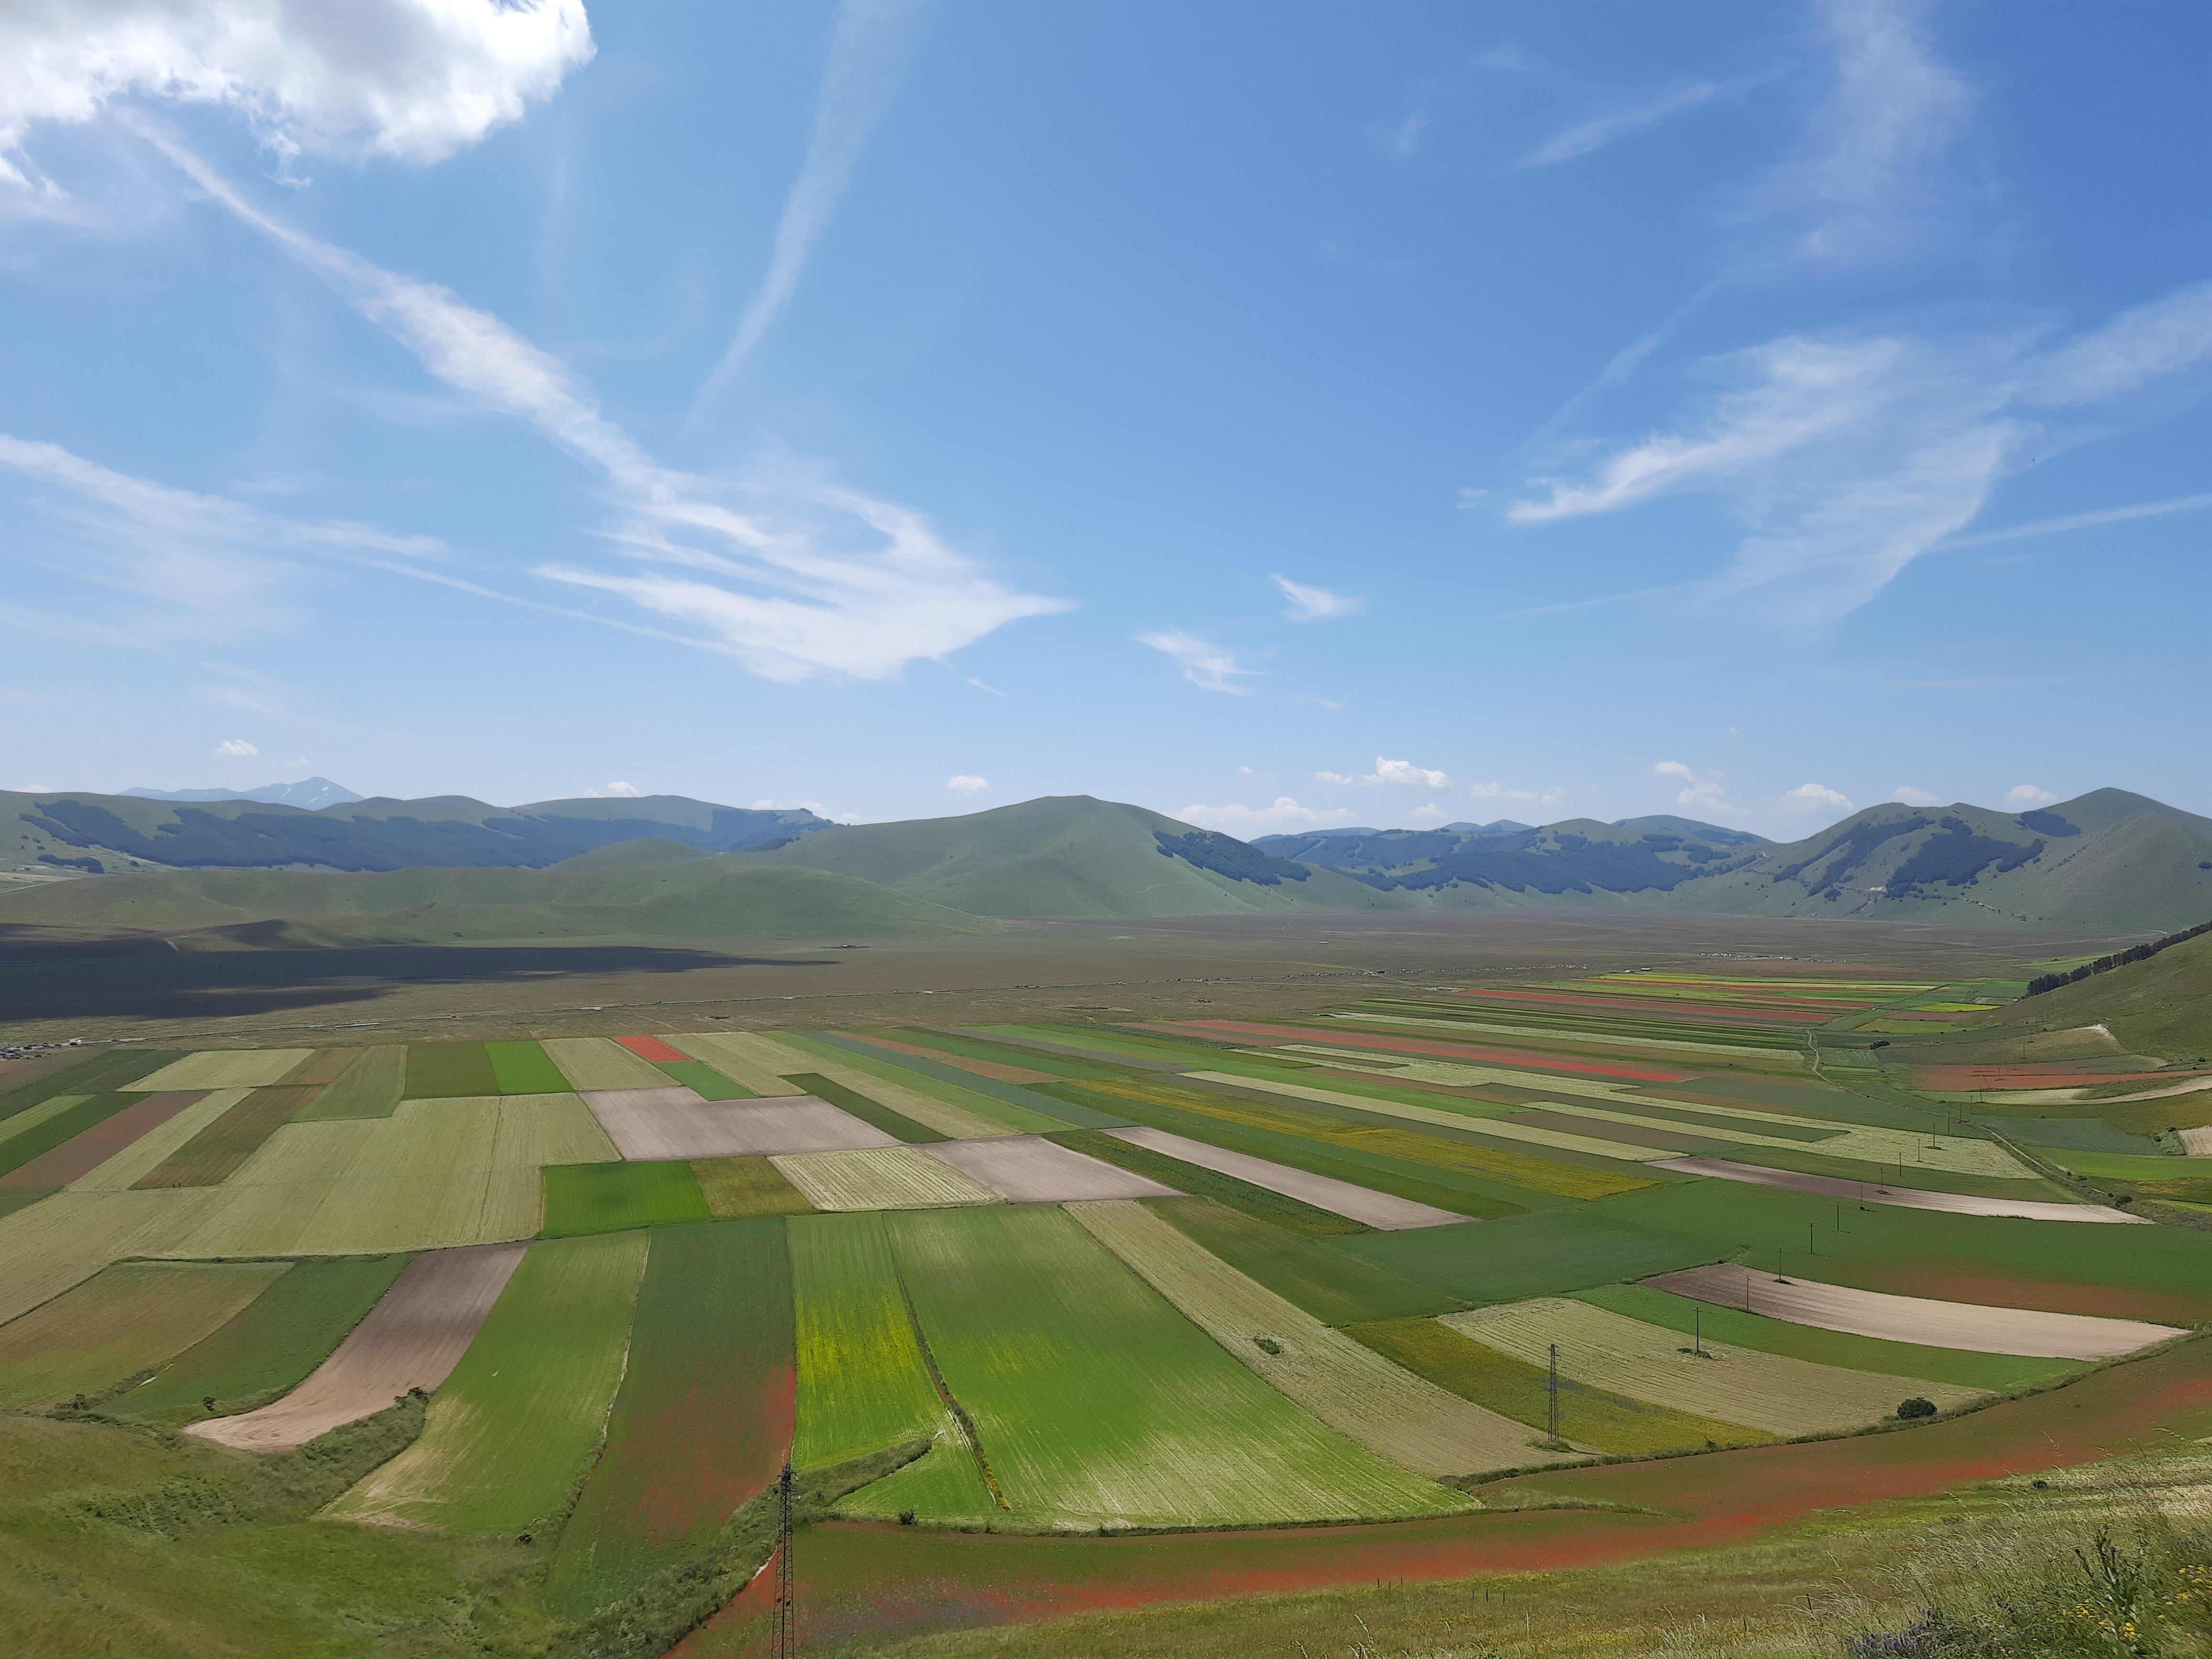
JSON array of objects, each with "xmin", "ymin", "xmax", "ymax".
[{"xmin": 787, "ymin": 1215, "xmax": 995, "ymax": 1520}]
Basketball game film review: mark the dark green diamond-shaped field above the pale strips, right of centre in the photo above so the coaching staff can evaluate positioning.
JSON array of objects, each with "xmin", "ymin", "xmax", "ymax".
[{"xmin": 1323, "ymin": 1181, "xmax": 1734, "ymax": 1303}]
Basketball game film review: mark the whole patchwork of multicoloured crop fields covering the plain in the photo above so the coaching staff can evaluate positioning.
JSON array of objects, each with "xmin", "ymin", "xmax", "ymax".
[{"xmin": 0, "ymin": 971, "xmax": 2212, "ymax": 1652}]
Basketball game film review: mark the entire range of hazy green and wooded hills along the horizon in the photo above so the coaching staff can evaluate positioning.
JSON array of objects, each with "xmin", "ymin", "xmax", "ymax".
[{"xmin": 0, "ymin": 790, "xmax": 2212, "ymax": 942}]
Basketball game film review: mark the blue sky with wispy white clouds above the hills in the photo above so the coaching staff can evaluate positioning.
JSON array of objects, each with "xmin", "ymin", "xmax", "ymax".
[{"xmin": 0, "ymin": 0, "xmax": 2212, "ymax": 838}]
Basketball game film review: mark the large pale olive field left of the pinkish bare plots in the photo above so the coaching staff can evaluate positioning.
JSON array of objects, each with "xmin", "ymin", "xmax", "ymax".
[{"xmin": 146, "ymin": 1095, "xmax": 615, "ymax": 1256}]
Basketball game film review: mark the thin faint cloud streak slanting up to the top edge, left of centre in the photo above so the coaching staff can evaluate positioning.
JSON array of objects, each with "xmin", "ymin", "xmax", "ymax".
[{"xmin": 695, "ymin": 0, "xmax": 922, "ymax": 411}]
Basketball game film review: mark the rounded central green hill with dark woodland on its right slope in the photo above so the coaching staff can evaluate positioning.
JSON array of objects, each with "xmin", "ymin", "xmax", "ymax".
[{"xmin": 752, "ymin": 794, "xmax": 1409, "ymax": 916}]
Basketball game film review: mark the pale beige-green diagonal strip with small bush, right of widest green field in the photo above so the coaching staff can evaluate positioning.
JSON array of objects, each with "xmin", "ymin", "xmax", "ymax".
[{"xmin": 1068, "ymin": 1201, "xmax": 1542, "ymax": 1475}]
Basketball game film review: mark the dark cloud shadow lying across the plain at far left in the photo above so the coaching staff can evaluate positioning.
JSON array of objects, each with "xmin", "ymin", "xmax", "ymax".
[{"xmin": 0, "ymin": 925, "xmax": 841, "ymax": 1020}]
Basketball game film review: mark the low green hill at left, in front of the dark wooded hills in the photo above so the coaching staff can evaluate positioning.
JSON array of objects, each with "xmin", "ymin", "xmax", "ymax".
[{"xmin": 0, "ymin": 858, "xmax": 993, "ymax": 944}]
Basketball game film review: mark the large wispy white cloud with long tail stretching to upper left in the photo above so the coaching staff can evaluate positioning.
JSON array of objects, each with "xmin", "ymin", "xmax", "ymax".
[{"xmin": 146, "ymin": 133, "xmax": 1068, "ymax": 681}]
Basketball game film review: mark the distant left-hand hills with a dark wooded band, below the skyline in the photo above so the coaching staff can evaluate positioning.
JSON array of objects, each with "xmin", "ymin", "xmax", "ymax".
[{"xmin": 0, "ymin": 790, "xmax": 825, "ymax": 874}]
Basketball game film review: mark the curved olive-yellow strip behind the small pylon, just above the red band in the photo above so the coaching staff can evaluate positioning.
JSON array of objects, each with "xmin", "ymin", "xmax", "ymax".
[{"xmin": 1345, "ymin": 1318, "xmax": 1774, "ymax": 1456}]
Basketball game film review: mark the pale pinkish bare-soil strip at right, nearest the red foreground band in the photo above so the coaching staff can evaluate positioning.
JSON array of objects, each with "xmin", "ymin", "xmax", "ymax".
[{"xmin": 1644, "ymin": 1263, "xmax": 2186, "ymax": 1360}]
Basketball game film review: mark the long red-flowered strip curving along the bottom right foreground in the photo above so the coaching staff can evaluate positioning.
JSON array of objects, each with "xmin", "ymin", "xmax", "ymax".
[{"xmin": 675, "ymin": 1340, "xmax": 2212, "ymax": 1659}]
